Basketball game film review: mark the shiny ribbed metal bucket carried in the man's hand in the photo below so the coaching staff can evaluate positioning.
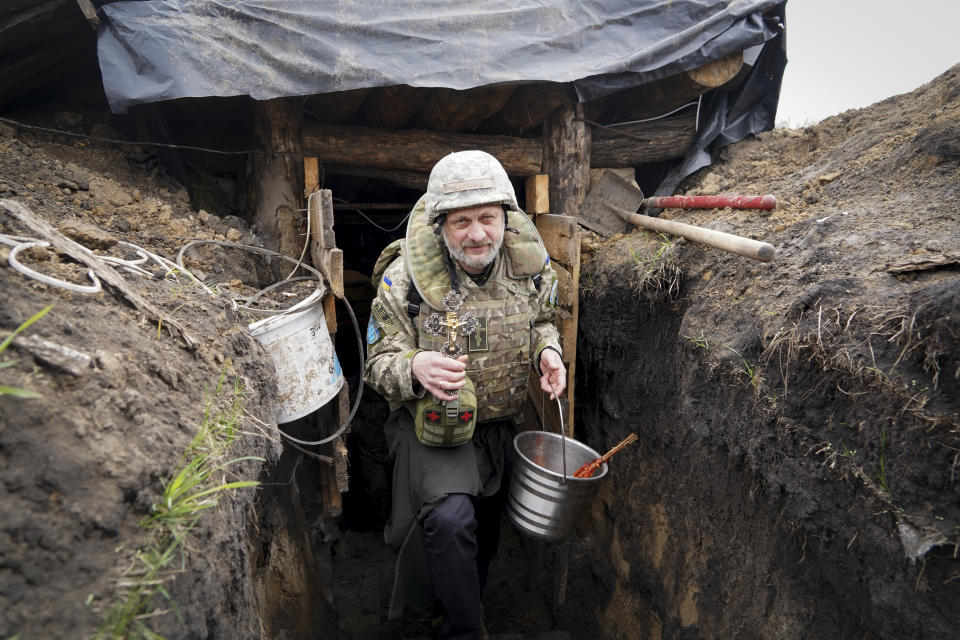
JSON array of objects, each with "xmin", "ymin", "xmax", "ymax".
[{"xmin": 507, "ymin": 431, "xmax": 607, "ymax": 542}]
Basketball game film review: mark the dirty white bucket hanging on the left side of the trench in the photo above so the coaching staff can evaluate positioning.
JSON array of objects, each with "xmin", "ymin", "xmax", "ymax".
[{"xmin": 249, "ymin": 289, "xmax": 343, "ymax": 424}]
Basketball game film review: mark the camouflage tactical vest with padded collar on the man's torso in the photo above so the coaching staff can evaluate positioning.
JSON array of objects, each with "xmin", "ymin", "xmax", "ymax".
[{"xmin": 377, "ymin": 198, "xmax": 549, "ymax": 422}]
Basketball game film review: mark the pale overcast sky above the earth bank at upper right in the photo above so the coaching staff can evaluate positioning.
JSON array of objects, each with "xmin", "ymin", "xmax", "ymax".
[{"xmin": 777, "ymin": 0, "xmax": 960, "ymax": 127}]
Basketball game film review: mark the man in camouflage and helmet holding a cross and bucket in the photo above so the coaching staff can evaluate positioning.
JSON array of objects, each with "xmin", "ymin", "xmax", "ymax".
[{"xmin": 364, "ymin": 151, "xmax": 566, "ymax": 639}]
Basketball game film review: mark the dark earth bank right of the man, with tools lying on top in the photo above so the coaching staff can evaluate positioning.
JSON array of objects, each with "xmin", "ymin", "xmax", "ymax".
[{"xmin": 568, "ymin": 61, "xmax": 960, "ymax": 638}]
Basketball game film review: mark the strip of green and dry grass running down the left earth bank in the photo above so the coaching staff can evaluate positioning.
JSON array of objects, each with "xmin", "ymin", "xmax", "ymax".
[{"xmin": 94, "ymin": 376, "xmax": 264, "ymax": 640}]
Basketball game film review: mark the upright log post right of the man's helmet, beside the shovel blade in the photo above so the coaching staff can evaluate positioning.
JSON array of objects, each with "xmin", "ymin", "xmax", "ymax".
[{"xmin": 543, "ymin": 104, "xmax": 588, "ymax": 214}]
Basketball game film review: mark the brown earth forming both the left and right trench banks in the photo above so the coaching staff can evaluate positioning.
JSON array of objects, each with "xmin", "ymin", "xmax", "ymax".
[{"xmin": 0, "ymin": 67, "xmax": 960, "ymax": 640}]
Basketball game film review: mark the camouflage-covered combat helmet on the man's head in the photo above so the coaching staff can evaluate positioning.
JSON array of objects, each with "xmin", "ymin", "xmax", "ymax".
[{"xmin": 424, "ymin": 151, "xmax": 520, "ymax": 224}]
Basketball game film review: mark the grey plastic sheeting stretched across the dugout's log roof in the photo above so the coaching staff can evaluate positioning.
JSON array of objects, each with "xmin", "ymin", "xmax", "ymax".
[{"xmin": 97, "ymin": 0, "xmax": 782, "ymax": 113}]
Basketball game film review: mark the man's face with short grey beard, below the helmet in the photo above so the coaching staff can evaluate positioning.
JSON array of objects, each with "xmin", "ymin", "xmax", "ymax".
[{"xmin": 442, "ymin": 204, "xmax": 504, "ymax": 273}]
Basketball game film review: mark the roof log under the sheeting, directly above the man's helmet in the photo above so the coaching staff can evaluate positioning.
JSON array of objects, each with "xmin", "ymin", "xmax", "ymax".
[{"xmin": 412, "ymin": 85, "xmax": 515, "ymax": 131}]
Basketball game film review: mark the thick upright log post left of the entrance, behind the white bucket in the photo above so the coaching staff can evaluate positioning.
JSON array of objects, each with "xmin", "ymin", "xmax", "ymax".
[{"xmin": 250, "ymin": 98, "xmax": 306, "ymax": 258}]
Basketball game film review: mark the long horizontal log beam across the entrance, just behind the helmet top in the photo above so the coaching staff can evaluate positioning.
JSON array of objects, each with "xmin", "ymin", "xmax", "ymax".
[{"xmin": 303, "ymin": 123, "xmax": 540, "ymax": 176}]
